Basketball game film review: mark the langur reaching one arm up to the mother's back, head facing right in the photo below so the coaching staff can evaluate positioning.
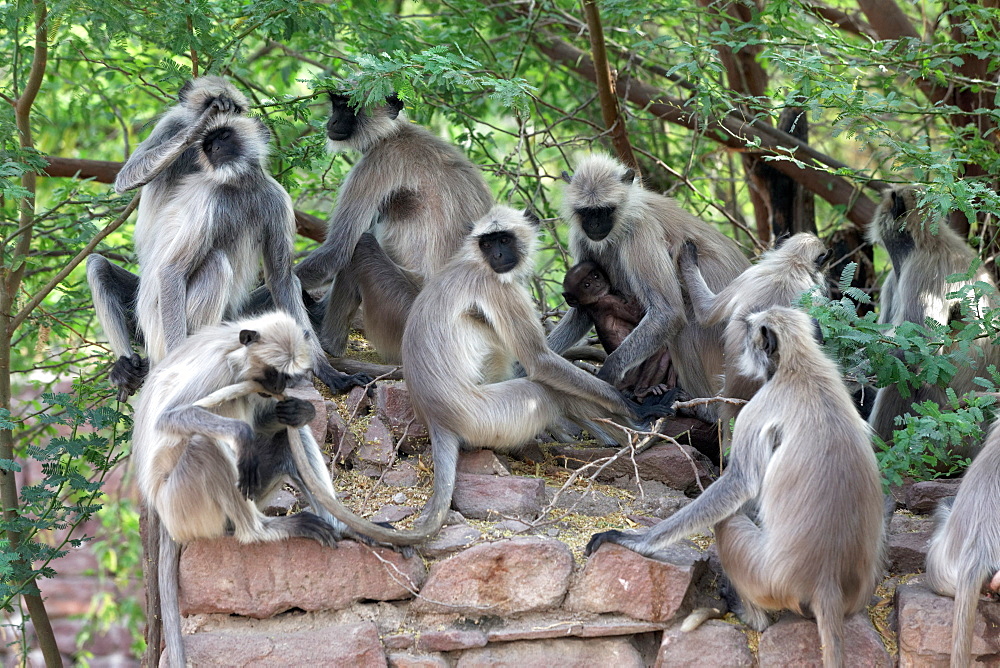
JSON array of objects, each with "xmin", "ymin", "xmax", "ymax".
[{"xmin": 677, "ymin": 232, "xmax": 830, "ymax": 428}]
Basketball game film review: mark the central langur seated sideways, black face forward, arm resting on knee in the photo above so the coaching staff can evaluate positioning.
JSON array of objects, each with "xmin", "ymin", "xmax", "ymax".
[{"xmin": 380, "ymin": 206, "xmax": 673, "ymax": 540}]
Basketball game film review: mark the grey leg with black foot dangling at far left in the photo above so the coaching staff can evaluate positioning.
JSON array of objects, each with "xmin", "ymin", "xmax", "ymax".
[{"xmin": 87, "ymin": 253, "xmax": 149, "ymax": 401}]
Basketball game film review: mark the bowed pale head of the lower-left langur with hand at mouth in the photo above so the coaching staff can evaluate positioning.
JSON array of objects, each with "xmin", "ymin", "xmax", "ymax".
[{"xmin": 227, "ymin": 311, "xmax": 313, "ymax": 394}]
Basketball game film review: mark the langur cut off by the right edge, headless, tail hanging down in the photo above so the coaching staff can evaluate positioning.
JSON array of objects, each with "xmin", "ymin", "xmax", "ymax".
[{"xmin": 927, "ymin": 423, "xmax": 1000, "ymax": 668}]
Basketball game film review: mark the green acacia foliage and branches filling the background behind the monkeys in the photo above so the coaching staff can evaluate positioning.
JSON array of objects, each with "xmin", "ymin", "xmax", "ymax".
[{"xmin": 0, "ymin": 0, "xmax": 1000, "ymax": 660}]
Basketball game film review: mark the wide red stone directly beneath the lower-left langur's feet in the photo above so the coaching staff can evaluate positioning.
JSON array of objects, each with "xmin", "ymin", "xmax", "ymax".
[{"xmin": 180, "ymin": 538, "xmax": 425, "ymax": 618}]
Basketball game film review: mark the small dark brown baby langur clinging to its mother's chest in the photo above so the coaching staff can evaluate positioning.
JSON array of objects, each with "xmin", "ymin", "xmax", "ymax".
[{"xmin": 563, "ymin": 262, "xmax": 677, "ymax": 399}]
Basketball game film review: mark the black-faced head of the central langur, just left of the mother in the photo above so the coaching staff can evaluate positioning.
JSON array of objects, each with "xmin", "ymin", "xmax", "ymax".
[{"xmin": 465, "ymin": 205, "xmax": 539, "ymax": 281}]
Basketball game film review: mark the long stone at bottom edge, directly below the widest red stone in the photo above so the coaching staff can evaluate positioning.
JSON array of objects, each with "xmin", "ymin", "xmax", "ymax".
[{"xmin": 178, "ymin": 622, "xmax": 386, "ymax": 668}]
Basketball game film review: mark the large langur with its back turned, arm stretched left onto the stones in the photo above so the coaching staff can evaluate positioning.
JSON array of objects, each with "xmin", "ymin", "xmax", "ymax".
[{"xmin": 587, "ymin": 307, "xmax": 884, "ymax": 668}]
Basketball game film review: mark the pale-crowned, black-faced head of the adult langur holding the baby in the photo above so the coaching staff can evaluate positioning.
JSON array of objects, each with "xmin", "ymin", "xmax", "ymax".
[{"xmin": 563, "ymin": 154, "xmax": 642, "ymax": 242}]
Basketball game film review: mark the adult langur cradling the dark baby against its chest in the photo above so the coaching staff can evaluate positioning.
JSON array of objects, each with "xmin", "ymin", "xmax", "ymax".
[{"xmin": 549, "ymin": 154, "xmax": 750, "ymax": 397}]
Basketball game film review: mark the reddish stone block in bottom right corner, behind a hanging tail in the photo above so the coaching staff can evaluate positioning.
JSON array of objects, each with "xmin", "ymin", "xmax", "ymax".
[{"xmin": 896, "ymin": 580, "xmax": 1000, "ymax": 668}]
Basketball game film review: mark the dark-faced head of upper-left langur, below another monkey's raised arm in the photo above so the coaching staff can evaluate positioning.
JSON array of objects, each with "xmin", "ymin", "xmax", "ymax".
[{"xmin": 198, "ymin": 113, "xmax": 271, "ymax": 181}]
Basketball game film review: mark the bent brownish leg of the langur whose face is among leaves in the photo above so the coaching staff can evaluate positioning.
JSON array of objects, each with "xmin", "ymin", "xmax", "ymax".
[{"xmin": 350, "ymin": 234, "xmax": 420, "ymax": 364}]
